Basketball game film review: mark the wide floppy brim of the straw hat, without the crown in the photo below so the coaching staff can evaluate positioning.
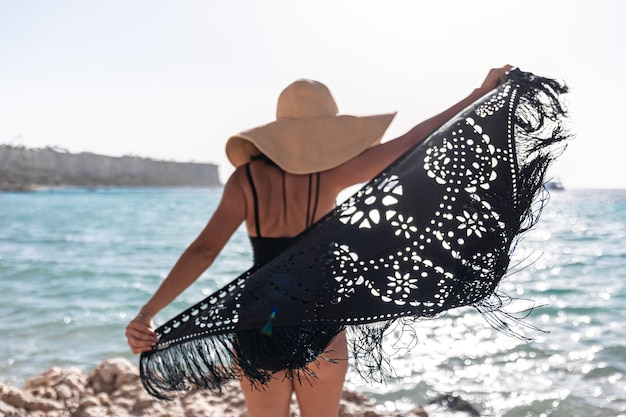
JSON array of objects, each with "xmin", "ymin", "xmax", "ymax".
[{"xmin": 226, "ymin": 113, "xmax": 396, "ymax": 174}]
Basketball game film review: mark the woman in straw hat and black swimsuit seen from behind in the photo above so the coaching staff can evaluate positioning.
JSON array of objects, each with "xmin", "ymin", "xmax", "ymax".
[{"xmin": 126, "ymin": 65, "xmax": 511, "ymax": 417}]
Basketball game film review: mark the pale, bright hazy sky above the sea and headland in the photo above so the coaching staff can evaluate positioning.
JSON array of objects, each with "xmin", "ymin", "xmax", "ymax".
[{"xmin": 0, "ymin": 0, "xmax": 626, "ymax": 188}]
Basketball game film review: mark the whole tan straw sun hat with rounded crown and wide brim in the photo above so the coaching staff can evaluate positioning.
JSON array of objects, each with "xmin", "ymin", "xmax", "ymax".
[{"xmin": 226, "ymin": 80, "xmax": 395, "ymax": 174}]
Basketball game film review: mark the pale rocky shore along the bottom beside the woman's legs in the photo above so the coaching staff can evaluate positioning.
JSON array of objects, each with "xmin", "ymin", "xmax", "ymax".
[{"xmin": 0, "ymin": 358, "xmax": 428, "ymax": 417}]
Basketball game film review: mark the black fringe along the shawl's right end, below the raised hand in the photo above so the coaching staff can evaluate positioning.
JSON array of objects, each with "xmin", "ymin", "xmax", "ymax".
[{"xmin": 473, "ymin": 69, "xmax": 573, "ymax": 334}]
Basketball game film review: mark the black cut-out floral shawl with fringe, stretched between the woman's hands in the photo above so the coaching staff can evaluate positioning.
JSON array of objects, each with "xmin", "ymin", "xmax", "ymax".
[{"xmin": 140, "ymin": 69, "xmax": 569, "ymax": 398}]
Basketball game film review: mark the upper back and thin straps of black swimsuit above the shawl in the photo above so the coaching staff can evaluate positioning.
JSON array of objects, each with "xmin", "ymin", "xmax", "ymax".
[{"xmin": 246, "ymin": 164, "xmax": 320, "ymax": 265}]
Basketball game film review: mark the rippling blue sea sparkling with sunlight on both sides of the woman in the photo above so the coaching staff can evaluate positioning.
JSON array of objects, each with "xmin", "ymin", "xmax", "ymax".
[{"xmin": 0, "ymin": 187, "xmax": 626, "ymax": 417}]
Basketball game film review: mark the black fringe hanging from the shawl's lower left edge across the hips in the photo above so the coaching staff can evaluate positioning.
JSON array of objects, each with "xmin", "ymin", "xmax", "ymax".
[{"xmin": 139, "ymin": 325, "xmax": 344, "ymax": 400}]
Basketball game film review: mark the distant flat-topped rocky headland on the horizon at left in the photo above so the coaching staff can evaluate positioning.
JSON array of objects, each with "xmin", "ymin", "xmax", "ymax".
[{"xmin": 0, "ymin": 145, "xmax": 221, "ymax": 191}]
